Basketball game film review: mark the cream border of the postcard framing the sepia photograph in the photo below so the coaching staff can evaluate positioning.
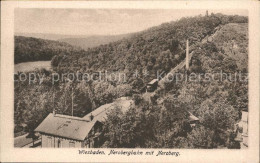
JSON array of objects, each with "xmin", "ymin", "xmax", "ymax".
[{"xmin": 0, "ymin": 1, "xmax": 260, "ymax": 162}]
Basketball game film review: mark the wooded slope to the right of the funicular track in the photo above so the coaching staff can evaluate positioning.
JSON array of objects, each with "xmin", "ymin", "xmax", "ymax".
[{"xmin": 101, "ymin": 23, "xmax": 248, "ymax": 148}]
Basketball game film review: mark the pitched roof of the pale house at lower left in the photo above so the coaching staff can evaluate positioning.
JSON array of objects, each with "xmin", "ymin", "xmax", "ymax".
[{"xmin": 35, "ymin": 113, "xmax": 96, "ymax": 141}]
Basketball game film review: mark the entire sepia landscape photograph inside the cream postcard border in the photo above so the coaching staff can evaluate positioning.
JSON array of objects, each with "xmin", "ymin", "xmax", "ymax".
[{"xmin": 14, "ymin": 8, "xmax": 249, "ymax": 149}]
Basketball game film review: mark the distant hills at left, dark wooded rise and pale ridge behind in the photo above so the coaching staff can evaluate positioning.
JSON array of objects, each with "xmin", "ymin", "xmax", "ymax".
[{"xmin": 14, "ymin": 34, "xmax": 131, "ymax": 64}]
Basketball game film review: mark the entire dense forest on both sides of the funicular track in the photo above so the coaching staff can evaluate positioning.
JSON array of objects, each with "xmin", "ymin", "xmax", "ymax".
[{"xmin": 14, "ymin": 14, "xmax": 248, "ymax": 148}]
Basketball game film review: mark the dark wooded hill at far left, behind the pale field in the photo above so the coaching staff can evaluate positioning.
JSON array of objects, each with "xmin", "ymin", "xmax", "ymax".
[{"xmin": 14, "ymin": 36, "xmax": 80, "ymax": 64}]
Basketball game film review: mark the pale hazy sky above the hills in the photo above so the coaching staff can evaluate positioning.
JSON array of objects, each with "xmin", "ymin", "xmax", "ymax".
[{"xmin": 15, "ymin": 8, "xmax": 247, "ymax": 35}]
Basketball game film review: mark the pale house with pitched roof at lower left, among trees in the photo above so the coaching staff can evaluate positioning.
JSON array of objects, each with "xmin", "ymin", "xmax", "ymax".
[{"xmin": 35, "ymin": 113, "xmax": 102, "ymax": 148}]
